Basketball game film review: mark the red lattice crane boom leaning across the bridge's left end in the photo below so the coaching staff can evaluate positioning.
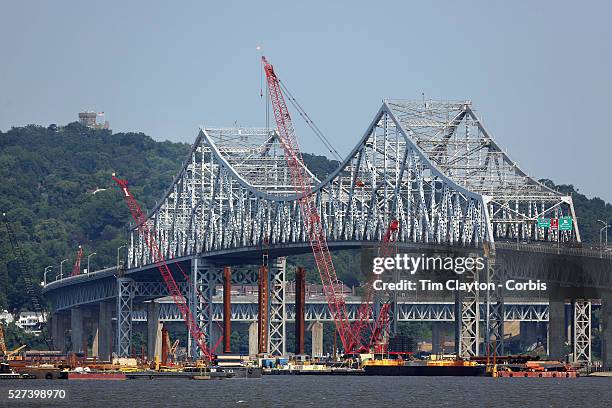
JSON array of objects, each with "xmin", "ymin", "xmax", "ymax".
[{"xmin": 112, "ymin": 173, "xmax": 214, "ymax": 361}]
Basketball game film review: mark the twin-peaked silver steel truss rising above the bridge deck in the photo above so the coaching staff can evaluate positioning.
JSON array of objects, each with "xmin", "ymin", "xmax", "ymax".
[{"xmin": 128, "ymin": 100, "xmax": 580, "ymax": 355}]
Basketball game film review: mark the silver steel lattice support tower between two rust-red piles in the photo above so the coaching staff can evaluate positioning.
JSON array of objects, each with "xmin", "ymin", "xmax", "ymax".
[{"xmin": 269, "ymin": 258, "xmax": 287, "ymax": 356}]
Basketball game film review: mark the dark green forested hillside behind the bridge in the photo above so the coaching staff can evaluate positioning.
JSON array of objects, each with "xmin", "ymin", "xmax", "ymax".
[{"xmin": 0, "ymin": 123, "xmax": 612, "ymax": 311}]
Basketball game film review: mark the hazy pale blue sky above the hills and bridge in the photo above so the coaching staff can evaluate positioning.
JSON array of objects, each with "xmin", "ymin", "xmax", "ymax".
[{"xmin": 0, "ymin": 0, "xmax": 612, "ymax": 201}]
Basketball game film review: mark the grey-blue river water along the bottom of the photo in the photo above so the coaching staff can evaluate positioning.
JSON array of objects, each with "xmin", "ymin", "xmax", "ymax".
[{"xmin": 0, "ymin": 376, "xmax": 612, "ymax": 408}]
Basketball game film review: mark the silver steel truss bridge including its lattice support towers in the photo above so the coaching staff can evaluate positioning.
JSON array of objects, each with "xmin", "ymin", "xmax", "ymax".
[{"xmin": 45, "ymin": 100, "xmax": 612, "ymax": 361}]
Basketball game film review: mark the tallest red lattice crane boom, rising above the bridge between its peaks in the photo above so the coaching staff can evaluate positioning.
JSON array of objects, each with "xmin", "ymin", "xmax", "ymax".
[{"xmin": 261, "ymin": 56, "xmax": 361, "ymax": 352}]
